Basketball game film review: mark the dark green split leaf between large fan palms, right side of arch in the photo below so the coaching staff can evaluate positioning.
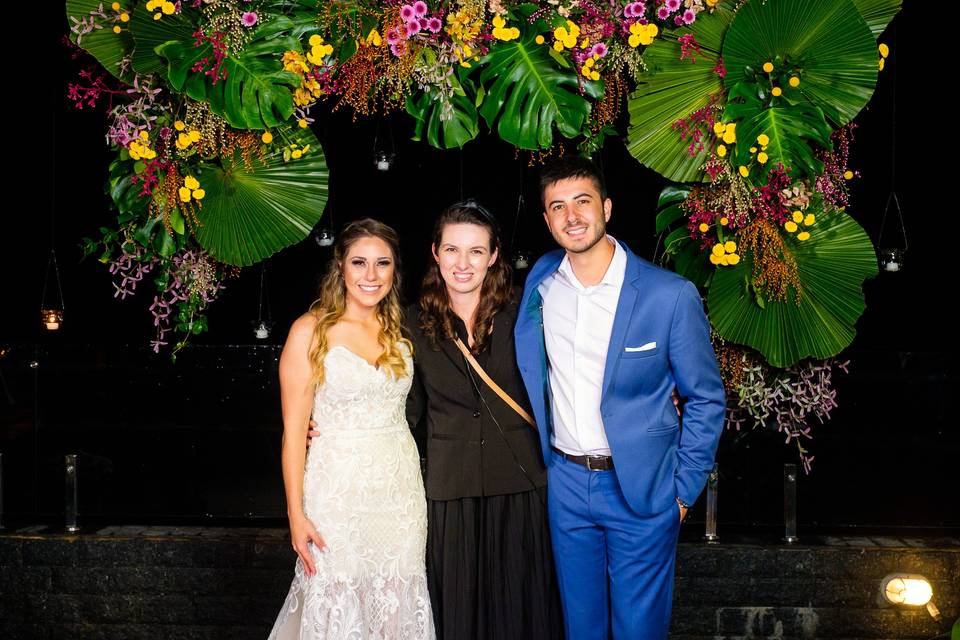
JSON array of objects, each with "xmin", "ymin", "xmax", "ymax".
[{"xmin": 723, "ymin": 82, "xmax": 833, "ymax": 184}]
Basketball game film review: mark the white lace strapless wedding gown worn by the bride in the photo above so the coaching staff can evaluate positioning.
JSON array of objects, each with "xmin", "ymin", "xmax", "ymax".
[{"xmin": 270, "ymin": 345, "xmax": 434, "ymax": 640}]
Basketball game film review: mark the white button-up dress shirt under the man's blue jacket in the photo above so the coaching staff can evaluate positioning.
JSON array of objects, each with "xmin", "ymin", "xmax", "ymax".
[{"xmin": 538, "ymin": 235, "xmax": 627, "ymax": 456}]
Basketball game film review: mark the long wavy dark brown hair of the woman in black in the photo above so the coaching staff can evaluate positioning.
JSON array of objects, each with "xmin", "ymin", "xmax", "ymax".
[{"xmin": 417, "ymin": 200, "xmax": 513, "ymax": 353}]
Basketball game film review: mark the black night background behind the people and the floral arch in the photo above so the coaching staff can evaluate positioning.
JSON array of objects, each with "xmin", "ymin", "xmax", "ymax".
[{"xmin": 0, "ymin": 3, "xmax": 960, "ymax": 530}]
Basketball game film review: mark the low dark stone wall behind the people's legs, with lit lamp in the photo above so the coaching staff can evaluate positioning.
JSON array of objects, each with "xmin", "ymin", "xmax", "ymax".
[{"xmin": 0, "ymin": 527, "xmax": 960, "ymax": 640}]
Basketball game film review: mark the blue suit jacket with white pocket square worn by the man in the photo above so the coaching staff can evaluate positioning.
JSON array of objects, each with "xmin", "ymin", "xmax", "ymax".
[{"xmin": 515, "ymin": 246, "xmax": 725, "ymax": 516}]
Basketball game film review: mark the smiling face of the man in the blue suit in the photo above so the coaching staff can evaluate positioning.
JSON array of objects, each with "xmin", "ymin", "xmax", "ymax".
[{"xmin": 543, "ymin": 178, "xmax": 613, "ymax": 253}]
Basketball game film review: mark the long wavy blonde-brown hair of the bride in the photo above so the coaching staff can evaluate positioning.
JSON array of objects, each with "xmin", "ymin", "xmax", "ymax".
[{"xmin": 310, "ymin": 218, "xmax": 413, "ymax": 385}]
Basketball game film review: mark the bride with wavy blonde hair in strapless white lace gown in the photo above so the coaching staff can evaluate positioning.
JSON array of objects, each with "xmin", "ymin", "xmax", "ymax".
[{"xmin": 270, "ymin": 219, "xmax": 434, "ymax": 640}]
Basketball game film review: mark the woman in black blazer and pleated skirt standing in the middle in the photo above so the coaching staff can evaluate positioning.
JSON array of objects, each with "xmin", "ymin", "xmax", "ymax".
[{"xmin": 407, "ymin": 200, "xmax": 563, "ymax": 640}]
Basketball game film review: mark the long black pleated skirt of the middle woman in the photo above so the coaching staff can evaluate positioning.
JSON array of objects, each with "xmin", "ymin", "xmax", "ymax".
[{"xmin": 427, "ymin": 489, "xmax": 563, "ymax": 640}]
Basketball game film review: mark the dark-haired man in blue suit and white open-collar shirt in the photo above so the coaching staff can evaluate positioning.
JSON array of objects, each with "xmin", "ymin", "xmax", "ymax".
[{"xmin": 515, "ymin": 158, "xmax": 724, "ymax": 640}]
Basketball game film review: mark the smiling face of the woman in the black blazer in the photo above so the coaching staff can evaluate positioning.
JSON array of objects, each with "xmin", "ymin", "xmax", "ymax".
[{"xmin": 431, "ymin": 222, "xmax": 498, "ymax": 294}]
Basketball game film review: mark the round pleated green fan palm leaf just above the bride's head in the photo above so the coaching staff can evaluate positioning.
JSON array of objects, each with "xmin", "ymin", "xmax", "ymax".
[{"xmin": 196, "ymin": 127, "xmax": 329, "ymax": 267}]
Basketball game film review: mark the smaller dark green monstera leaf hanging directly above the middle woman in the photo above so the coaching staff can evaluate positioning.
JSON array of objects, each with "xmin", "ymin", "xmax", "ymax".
[{"xmin": 407, "ymin": 59, "xmax": 480, "ymax": 149}]
